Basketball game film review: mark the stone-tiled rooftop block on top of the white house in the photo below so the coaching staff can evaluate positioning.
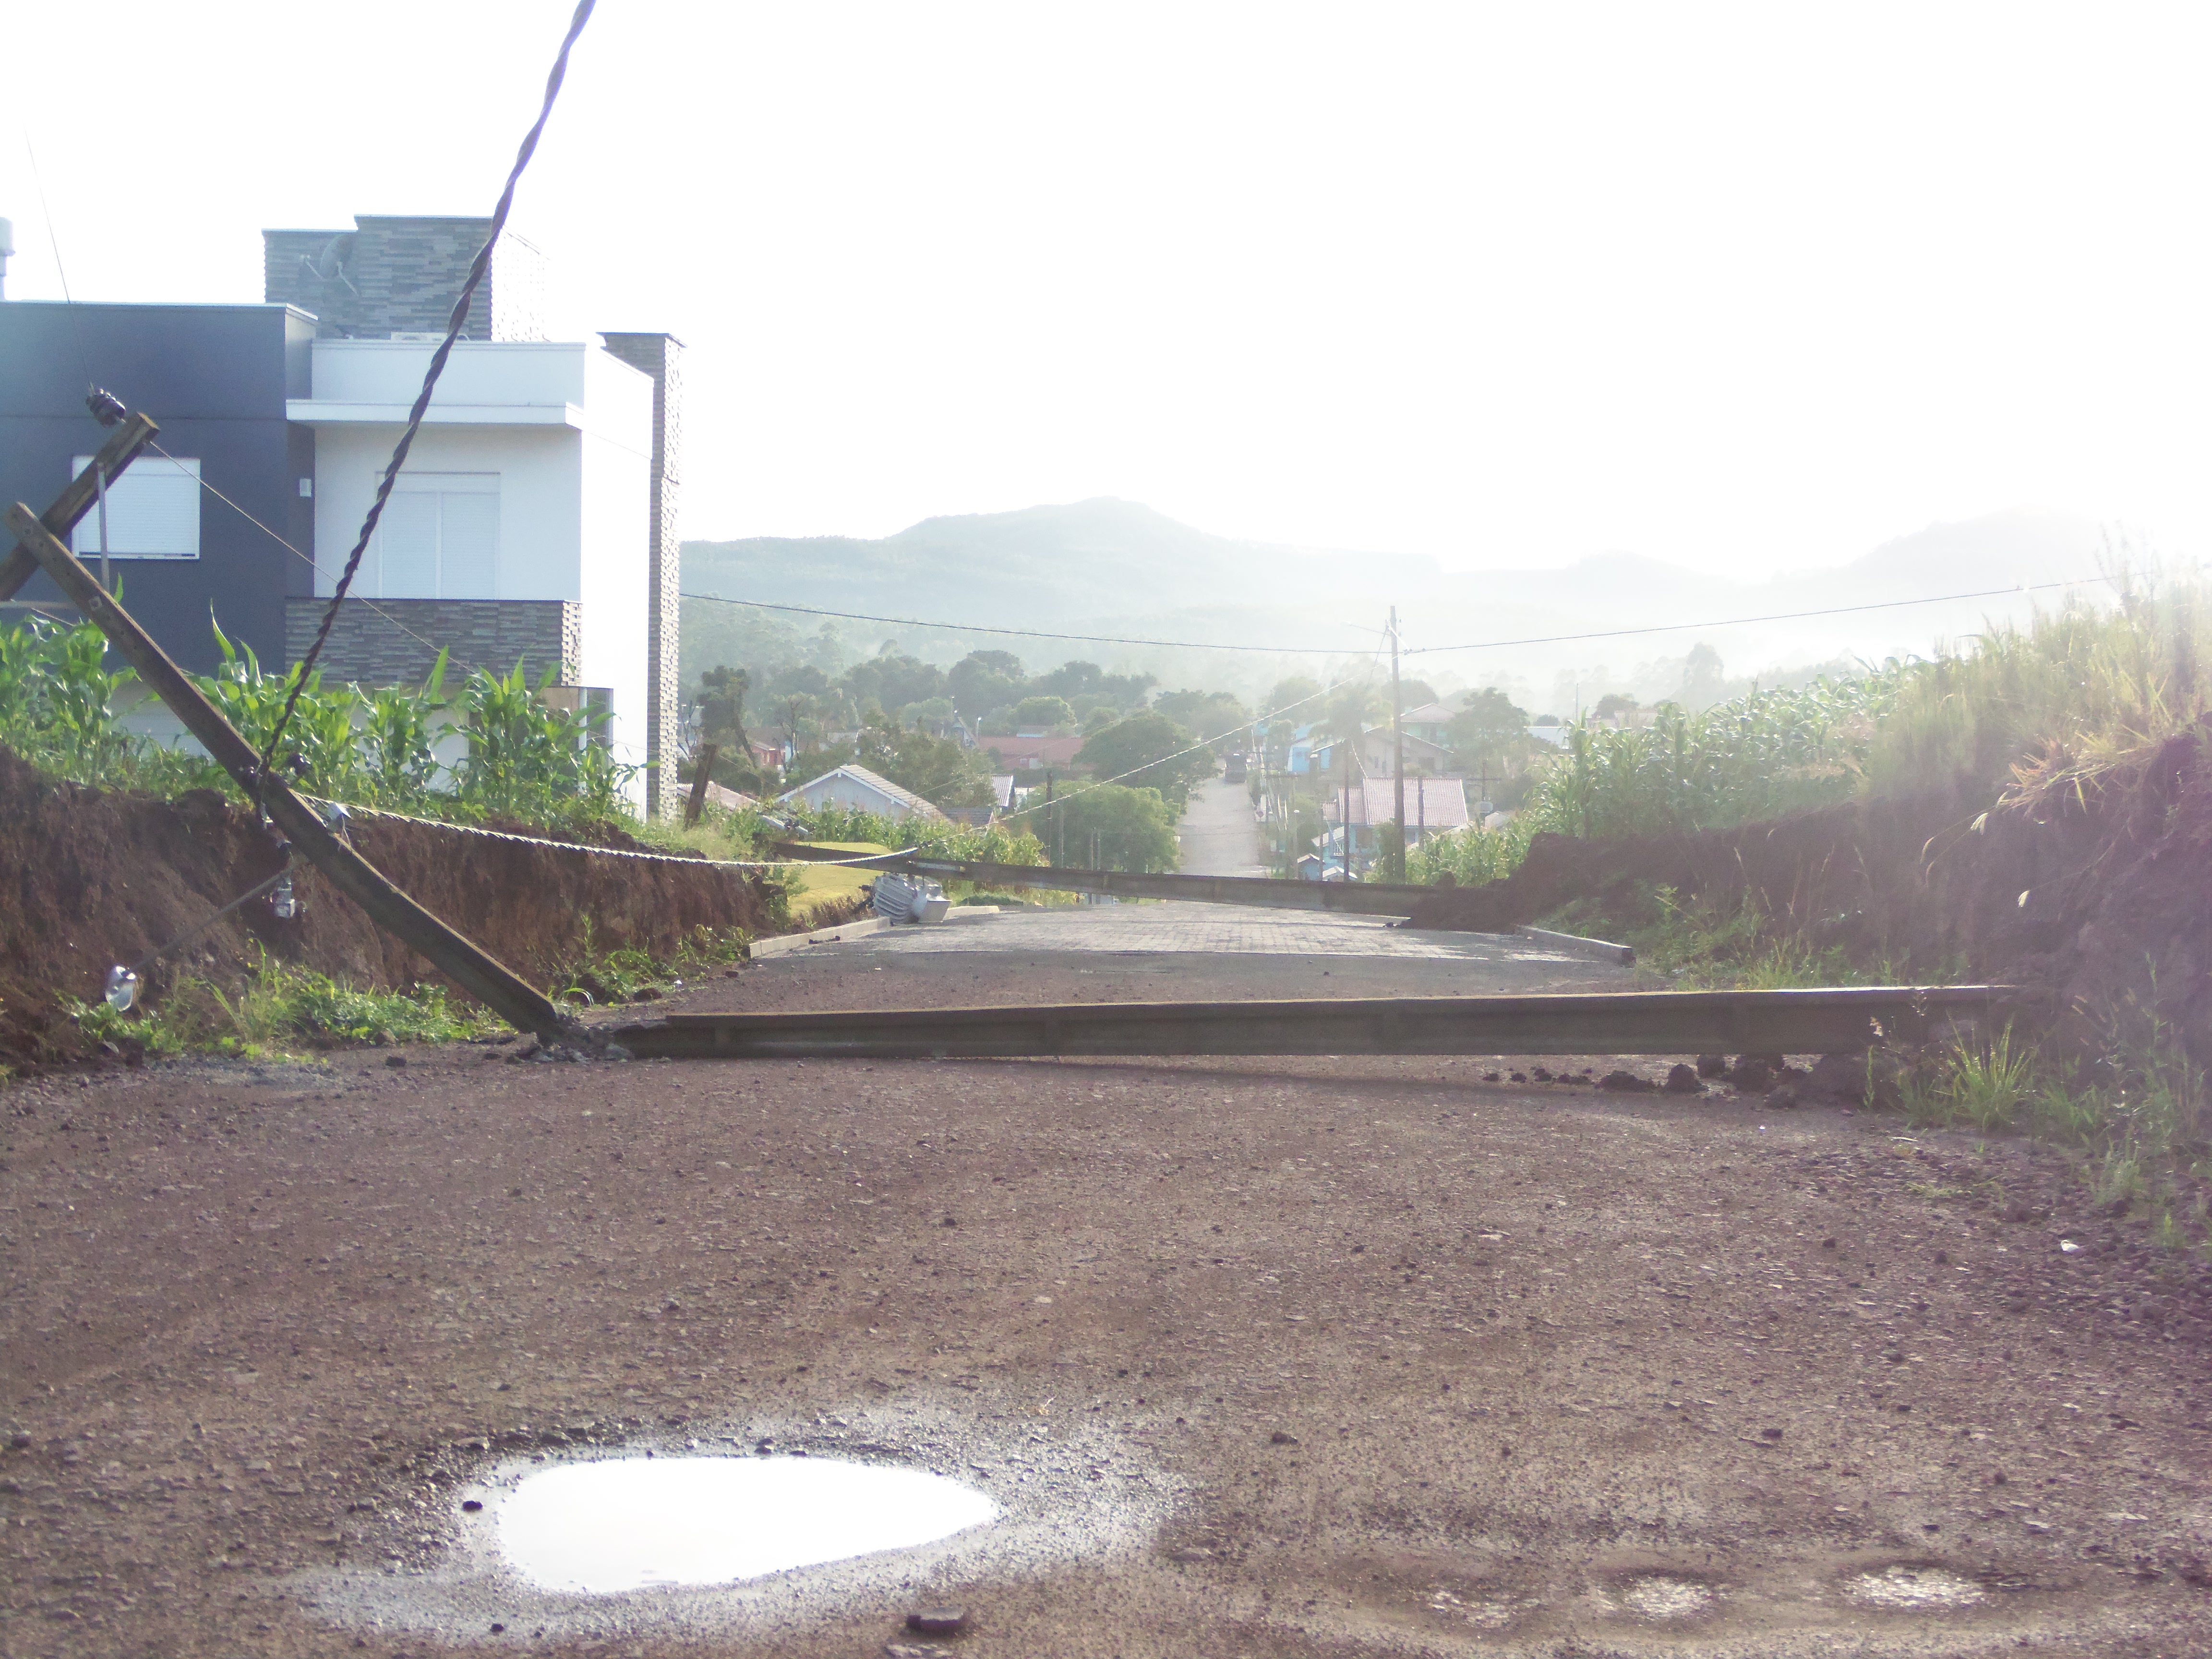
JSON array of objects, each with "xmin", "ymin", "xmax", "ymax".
[{"xmin": 261, "ymin": 215, "xmax": 546, "ymax": 341}]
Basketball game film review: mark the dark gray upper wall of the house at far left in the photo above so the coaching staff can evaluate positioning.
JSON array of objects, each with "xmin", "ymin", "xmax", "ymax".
[{"xmin": 0, "ymin": 301, "xmax": 314, "ymax": 673}]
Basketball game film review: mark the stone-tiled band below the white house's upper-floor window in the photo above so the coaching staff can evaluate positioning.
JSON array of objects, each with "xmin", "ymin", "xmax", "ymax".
[{"xmin": 285, "ymin": 597, "xmax": 584, "ymax": 685}]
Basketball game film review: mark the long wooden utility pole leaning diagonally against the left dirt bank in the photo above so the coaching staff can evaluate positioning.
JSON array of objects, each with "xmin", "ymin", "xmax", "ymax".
[{"xmin": 7, "ymin": 493, "xmax": 573, "ymax": 1037}]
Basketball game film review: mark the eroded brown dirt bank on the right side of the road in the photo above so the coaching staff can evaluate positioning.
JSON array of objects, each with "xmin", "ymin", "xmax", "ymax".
[{"xmin": 1414, "ymin": 736, "xmax": 2212, "ymax": 1062}]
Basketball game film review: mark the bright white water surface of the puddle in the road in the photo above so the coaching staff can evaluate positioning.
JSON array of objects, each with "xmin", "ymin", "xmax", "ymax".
[{"xmin": 495, "ymin": 1458, "xmax": 998, "ymax": 1595}]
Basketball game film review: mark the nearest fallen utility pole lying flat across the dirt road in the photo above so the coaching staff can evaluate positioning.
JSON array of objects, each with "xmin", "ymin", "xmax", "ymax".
[{"xmin": 608, "ymin": 985, "xmax": 2008, "ymax": 1059}]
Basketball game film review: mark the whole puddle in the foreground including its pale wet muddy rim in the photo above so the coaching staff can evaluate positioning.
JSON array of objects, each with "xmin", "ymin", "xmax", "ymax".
[{"xmin": 307, "ymin": 1407, "xmax": 1183, "ymax": 1644}]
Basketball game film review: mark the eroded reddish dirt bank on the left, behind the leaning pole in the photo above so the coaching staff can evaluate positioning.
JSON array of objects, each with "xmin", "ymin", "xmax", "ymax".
[{"xmin": 0, "ymin": 750, "xmax": 770, "ymax": 1064}]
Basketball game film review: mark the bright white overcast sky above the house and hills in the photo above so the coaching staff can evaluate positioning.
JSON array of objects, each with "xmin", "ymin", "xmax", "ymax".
[{"xmin": 0, "ymin": 0, "xmax": 2212, "ymax": 575}]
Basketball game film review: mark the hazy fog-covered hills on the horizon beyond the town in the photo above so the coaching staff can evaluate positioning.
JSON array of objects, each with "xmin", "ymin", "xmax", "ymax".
[{"xmin": 684, "ymin": 498, "xmax": 2108, "ymax": 712}]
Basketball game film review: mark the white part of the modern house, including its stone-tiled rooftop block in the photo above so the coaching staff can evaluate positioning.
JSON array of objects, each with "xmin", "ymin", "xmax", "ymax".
[{"xmin": 261, "ymin": 217, "xmax": 681, "ymax": 812}]
